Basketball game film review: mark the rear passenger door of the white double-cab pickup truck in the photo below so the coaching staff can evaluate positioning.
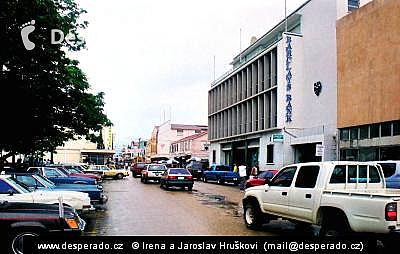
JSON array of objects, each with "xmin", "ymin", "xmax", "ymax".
[{"xmin": 289, "ymin": 165, "xmax": 320, "ymax": 222}]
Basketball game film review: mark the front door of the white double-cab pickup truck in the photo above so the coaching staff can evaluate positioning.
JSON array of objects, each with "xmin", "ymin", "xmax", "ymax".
[{"xmin": 261, "ymin": 166, "xmax": 297, "ymax": 215}]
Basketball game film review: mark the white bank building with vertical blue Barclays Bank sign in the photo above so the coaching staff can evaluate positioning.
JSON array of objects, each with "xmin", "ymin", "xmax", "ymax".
[{"xmin": 208, "ymin": 0, "xmax": 370, "ymax": 170}]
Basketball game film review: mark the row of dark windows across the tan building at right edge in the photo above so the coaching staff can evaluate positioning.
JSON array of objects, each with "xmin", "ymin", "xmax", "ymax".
[{"xmin": 340, "ymin": 120, "xmax": 400, "ymax": 141}]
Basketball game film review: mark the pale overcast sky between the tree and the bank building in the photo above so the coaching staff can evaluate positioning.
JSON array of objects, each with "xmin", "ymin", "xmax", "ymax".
[{"xmin": 72, "ymin": 0, "xmax": 305, "ymax": 149}]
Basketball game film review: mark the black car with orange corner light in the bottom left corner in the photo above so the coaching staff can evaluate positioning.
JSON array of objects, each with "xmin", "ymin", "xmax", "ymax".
[{"xmin": 0, "ymin": 201, "xmax": 86, "ymax": 253}]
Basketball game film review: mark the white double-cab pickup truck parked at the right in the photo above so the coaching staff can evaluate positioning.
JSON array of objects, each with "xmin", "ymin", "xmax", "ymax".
[{"xmin": 242, "ymin": 161, "xmax": 400, "ymax": 236}]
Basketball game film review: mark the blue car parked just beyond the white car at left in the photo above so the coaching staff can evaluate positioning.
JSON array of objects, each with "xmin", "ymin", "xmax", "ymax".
[{"xmin": 8, "ymin": 172, "xmax": 108, "ymax": 208}]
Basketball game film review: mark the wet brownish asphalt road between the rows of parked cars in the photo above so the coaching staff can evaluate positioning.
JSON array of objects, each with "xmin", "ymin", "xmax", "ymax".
[{"xmin": 84, "ymin": 176, "xmax": 314, "ymax": 236}]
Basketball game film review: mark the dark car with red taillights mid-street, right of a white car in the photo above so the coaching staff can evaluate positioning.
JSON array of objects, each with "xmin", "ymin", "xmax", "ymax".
[{"xmin": 160, "ymin": 168, "xmax": 193, "ymax": 190}]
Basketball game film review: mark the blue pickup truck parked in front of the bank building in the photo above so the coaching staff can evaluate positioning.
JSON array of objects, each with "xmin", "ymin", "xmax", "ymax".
[{"xmin": 203, "ymin": 164, "xmax": 240, "ymax": 185}]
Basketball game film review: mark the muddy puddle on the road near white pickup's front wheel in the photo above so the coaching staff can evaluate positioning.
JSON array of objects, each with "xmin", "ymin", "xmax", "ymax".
[{"xmin": 194, "ymin": 191, "xmax": 242, "ymax": 217}]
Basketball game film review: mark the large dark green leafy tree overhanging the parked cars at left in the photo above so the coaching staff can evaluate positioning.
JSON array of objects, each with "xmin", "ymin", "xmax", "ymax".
[{"xmin": 0, "ymin": 0, "xmax": 112, "ymax": 167}]
